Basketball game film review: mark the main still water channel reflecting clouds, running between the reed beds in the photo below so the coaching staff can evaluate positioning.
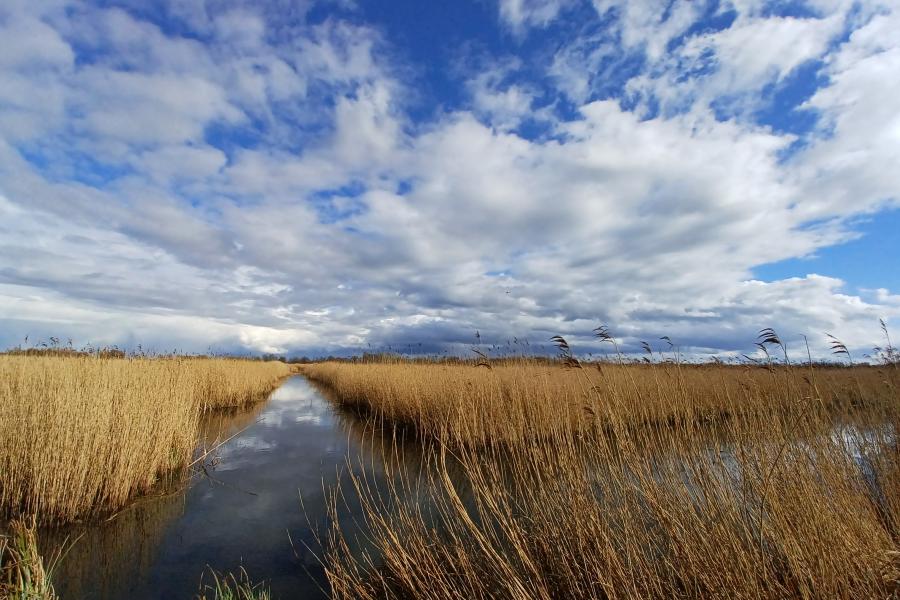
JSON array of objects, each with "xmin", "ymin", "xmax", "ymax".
[{"xmin": 54, "ymin": 376, "xmax": 377, "ymax": 600}]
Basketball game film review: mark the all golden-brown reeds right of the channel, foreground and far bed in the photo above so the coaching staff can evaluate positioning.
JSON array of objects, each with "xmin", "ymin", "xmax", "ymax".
[{"xmin": 303, "ymin": 360, "xmax": 900, "ymax": 600}]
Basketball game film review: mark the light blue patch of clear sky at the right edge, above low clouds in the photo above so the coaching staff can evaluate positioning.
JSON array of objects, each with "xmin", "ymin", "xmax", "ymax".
[{"xmin": 753, "ymin": 207, "xmax": 900, "ymax": 293}]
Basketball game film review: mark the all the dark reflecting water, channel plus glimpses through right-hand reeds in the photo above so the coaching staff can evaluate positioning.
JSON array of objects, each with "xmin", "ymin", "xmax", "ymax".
[{"xmin": 43, "ymin": 376, "xmax": 894, "ymax": 600}]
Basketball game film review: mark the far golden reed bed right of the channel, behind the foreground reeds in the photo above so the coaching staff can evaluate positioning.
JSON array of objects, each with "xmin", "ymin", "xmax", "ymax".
[{"xmin": 301, "ymin": 360, "xmax": 900, "ymax": 445}]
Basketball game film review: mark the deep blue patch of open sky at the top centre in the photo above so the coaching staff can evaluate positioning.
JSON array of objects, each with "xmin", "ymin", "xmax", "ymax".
[{"xmin": 352, "ymin": 0, "xmax": 624, "ymax": 132}]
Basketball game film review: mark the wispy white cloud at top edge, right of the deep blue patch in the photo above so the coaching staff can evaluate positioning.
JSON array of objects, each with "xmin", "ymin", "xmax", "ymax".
[{"xmin": 584, "ymin": 0, "xmax": 852, "ymax": 116}]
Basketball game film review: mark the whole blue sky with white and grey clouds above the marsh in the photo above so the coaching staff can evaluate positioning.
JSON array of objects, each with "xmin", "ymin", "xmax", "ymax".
[{"xmin": 0, "ymin": 0, "xmax": 900, "ymax": 357}]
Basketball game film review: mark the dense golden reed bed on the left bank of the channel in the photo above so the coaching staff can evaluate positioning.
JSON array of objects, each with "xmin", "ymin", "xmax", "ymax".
[{"xmin": 0, "ymin": 354, "xmax": 290, "ymax": 524}]
